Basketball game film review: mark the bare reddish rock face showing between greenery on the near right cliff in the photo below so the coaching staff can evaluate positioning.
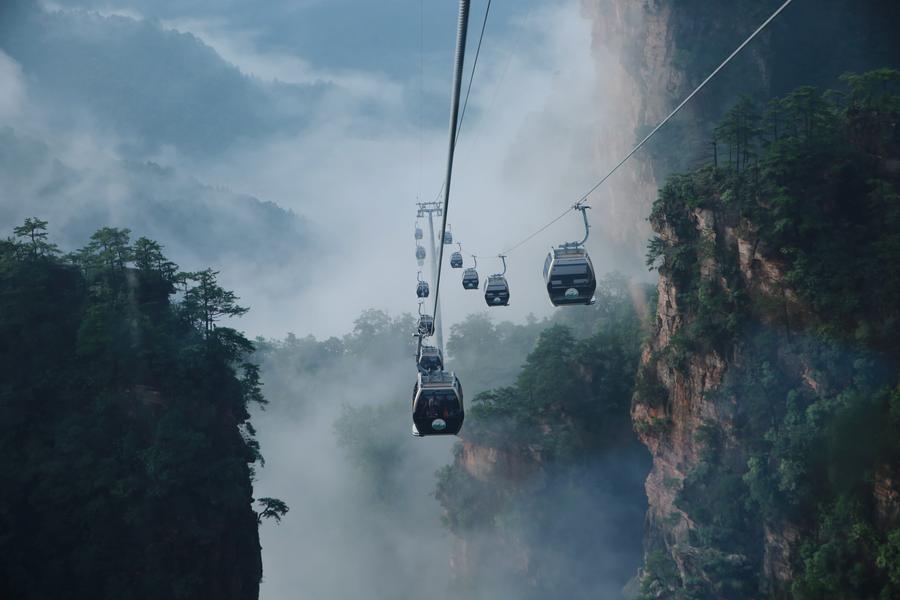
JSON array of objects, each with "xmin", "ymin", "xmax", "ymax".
[{"xmin": 632, "ymin": 199, "xmax": 800, "ymax": 589}]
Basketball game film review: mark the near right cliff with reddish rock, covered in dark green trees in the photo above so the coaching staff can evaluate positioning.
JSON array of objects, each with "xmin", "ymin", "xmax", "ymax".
[{"xmin": 632, "ymin": 69, "xmax": 900, "ymax": 599}]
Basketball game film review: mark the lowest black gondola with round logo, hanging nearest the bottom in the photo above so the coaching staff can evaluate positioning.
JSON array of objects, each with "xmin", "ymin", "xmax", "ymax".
[{"xmin": 412, "ymin": 371, "xmax": 465, "ymax": 437}]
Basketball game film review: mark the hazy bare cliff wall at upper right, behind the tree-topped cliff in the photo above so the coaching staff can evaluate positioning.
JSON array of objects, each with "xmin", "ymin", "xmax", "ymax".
[{"xmin": 582, "ymin": 0, "xmax": 900, "ymax": 253}]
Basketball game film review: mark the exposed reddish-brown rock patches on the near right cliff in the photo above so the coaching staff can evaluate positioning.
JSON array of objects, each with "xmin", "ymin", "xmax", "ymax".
[{"xmin": 631, "ymin": 184, "xmax": 800, "ymax": 587}]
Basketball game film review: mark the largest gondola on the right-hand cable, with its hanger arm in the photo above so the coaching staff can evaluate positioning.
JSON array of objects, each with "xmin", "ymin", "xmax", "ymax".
[{"xmin": 544, "ymin": 205, "xmax": 597, "ymax": 306}]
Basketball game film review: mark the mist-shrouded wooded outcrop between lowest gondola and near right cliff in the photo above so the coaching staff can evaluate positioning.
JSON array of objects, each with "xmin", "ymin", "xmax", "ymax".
[{"xmin": 436, "ymin": 277, "xmax": 649, "ymax": 599}]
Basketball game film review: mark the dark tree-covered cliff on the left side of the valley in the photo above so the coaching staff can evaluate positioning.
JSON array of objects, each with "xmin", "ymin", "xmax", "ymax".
[{"xmin": 0, "ymin": 218, "xmax": 278, "ymax": 600}]
